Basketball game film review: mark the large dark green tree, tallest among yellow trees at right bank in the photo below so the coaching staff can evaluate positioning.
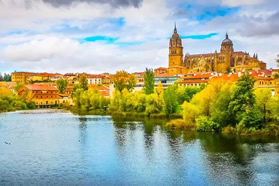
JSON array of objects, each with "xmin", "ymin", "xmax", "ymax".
[{"xmin": 228, "ymin": 74, "xmax": 260, "ymax": 128}]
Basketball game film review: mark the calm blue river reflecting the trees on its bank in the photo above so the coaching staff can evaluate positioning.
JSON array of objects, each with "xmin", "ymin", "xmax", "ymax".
[{"xmin": 0, "ymin": 110, "xmax": 279, "ymax": 185}]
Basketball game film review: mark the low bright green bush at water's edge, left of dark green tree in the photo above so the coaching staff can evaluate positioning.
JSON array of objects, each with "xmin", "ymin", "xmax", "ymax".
[{"xmin": 197, "ymin": 116, "xmax": 220, "ymax": 132}]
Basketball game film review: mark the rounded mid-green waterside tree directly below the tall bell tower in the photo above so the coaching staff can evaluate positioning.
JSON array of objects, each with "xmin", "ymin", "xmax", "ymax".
[{"xmin": 163, "ymin": 85, "xmax": 179, "ymax": 115}]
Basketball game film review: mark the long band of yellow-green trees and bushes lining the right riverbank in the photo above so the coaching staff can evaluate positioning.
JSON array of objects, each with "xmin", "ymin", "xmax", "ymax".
[{"xmin": 68, "ymin": 69, "xmax": 279, "ymax": 135}]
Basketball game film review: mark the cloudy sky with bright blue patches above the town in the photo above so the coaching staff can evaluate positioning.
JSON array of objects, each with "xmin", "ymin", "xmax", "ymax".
[{"xmin": 0, "ymin": 0, "xmax": 279, "ymax": 74}]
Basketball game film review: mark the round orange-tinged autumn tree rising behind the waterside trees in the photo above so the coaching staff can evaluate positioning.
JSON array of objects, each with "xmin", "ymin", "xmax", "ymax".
[{"xmin": 113, "ymin": 70, "xmax": 136, "ymax": 93}]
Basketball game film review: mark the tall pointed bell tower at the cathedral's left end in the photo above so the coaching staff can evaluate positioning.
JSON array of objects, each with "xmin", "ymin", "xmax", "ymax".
[{"xmin": 168, "ymin": 24, "xmax": 185, "ymax": 74}]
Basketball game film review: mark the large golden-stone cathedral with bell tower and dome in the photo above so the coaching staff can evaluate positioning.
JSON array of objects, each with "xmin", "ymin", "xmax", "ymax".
[{"xmin": 168, "ymin": 26, "xmax": 266, "ymax": 74}]
